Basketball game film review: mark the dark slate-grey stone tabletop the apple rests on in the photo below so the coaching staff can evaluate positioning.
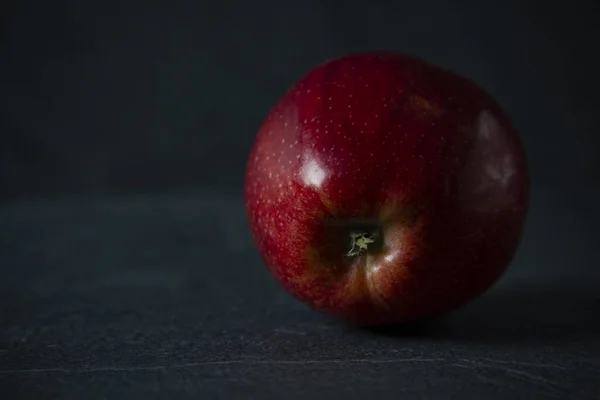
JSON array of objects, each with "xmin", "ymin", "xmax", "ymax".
[{"xmin": 0, "ymin": 187, "xmax": 600, "ymax": 400}]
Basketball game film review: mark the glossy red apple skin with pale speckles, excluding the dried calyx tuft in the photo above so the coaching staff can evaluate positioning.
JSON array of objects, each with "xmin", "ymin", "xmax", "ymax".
[{"xmin": 245, "ymin": 52, "xmax": 529, "ymax": 325}]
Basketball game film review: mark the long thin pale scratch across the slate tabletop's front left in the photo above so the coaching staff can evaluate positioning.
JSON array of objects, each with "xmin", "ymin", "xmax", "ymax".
[{"xmin": 0, "ymin": 358, "xmax": 444, "ymax": 374}]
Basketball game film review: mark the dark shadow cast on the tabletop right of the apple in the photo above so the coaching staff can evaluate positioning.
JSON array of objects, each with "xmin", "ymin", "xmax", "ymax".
[{"xmin": 352, "ymin": 287, "xmax": 600, "ymax": 343}]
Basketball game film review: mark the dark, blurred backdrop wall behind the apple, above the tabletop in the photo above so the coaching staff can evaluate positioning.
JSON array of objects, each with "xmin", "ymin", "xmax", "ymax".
[{"xmin": 0, "ymin": 0, "xmax": 600, "ymax": 197}]
